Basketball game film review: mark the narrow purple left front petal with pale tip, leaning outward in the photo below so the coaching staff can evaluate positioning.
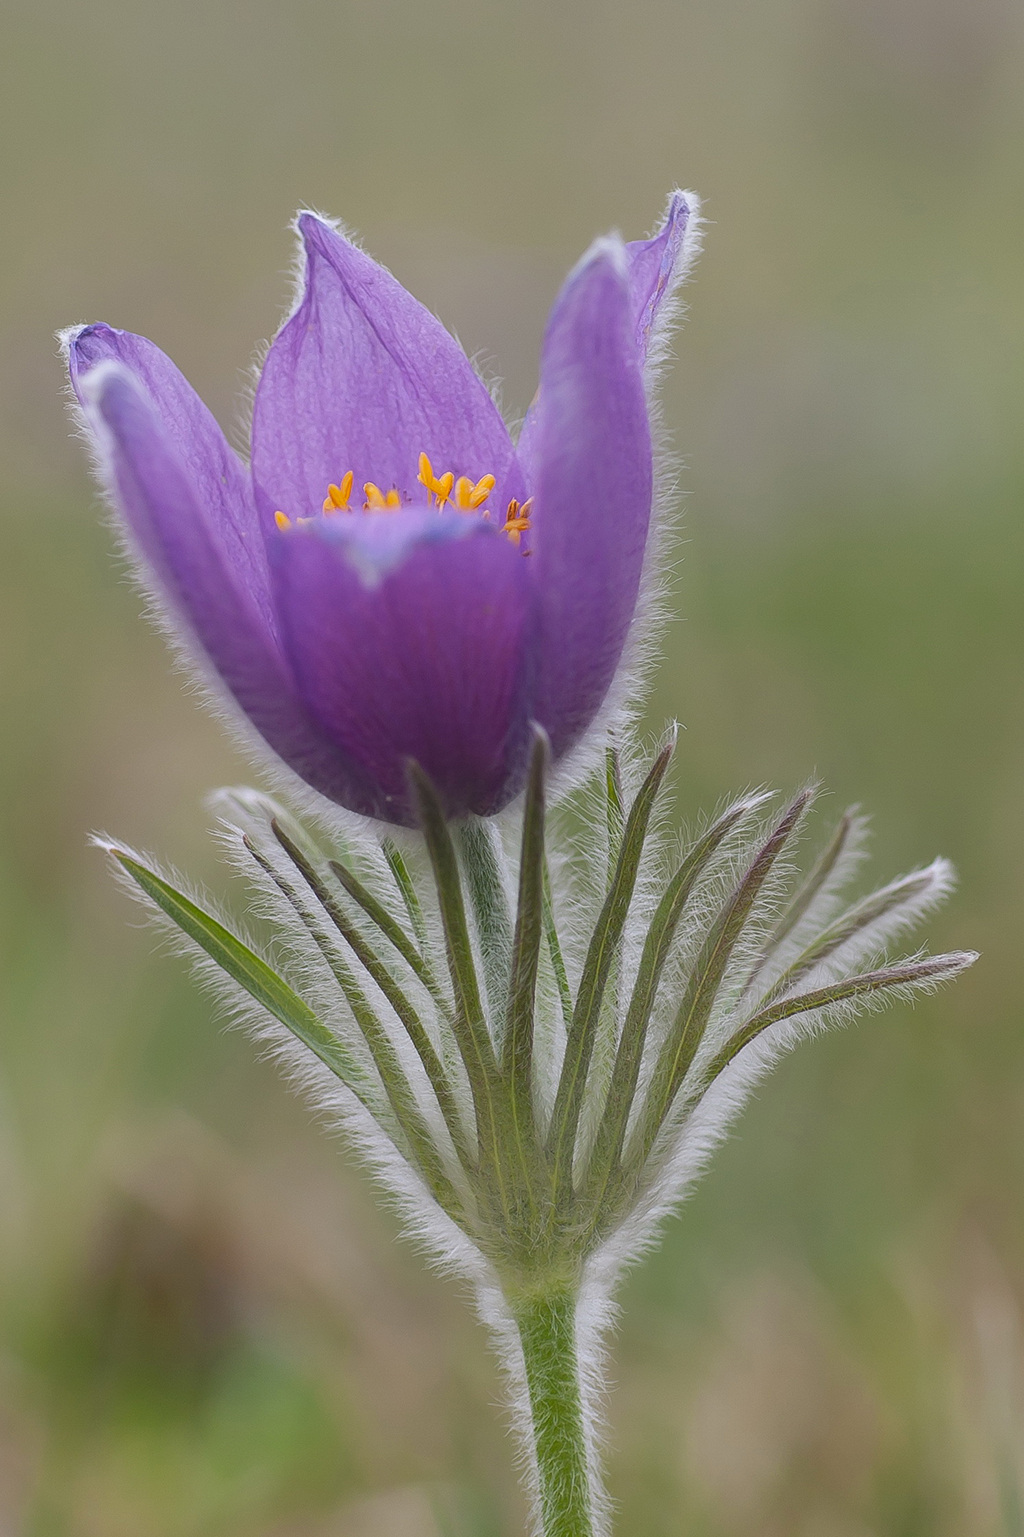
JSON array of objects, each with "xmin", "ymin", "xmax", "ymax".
[{"xmin": 78, "ymin": 361, "xmax": 382, "ymax": 805}]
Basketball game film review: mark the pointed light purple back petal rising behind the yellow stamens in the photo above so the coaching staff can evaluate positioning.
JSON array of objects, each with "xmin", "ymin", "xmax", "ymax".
[{"xmin": 252, "ymin": 214, "xmax": 523, "ymax": 521}]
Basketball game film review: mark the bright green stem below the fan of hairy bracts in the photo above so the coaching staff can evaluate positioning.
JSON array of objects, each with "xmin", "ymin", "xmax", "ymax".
[{"xmin": 512, "ymin": 1283, "xmax": 597, "ymax": 1537}]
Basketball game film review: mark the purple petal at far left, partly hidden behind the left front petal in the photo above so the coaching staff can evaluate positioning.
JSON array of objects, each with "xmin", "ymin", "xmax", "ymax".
[{"xmin": 68, "ymin": 324, "xmax": 272, "ymax": 622}]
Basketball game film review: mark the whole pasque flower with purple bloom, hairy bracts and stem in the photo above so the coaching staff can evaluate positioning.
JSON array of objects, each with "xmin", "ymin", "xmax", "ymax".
[{"xmin": 68, "ymin": 194, "xmax": 975, "ymax": 1537}]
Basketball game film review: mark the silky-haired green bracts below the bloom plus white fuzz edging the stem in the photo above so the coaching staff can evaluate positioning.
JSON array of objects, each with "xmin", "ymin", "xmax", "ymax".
[{"xmin": 97, "ymin": 732, "xmax": 975, "ymax": 1537}]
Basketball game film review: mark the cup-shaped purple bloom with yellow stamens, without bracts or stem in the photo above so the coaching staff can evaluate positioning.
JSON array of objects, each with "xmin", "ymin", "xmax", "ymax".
[{"xmin": 68, "ymin": 192, "xmax": 695, "ymax": 822}]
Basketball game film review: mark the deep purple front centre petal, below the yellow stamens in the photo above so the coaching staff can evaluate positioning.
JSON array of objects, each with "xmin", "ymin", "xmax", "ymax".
[{"xmin": 274, "ymin": 512, "xmax": 530, "ymax": 821}]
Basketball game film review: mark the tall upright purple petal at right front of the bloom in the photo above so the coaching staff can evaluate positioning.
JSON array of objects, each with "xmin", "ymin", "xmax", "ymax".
[{"xmin": 532, "ymin": 240, "xmax": 652, "ymax": 758}]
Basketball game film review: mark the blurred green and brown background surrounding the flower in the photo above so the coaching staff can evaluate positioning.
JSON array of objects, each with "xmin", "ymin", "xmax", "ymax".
[{"xmin": 0, "ymin": 0, "xmax": 1024, "ymax": 1537}]
